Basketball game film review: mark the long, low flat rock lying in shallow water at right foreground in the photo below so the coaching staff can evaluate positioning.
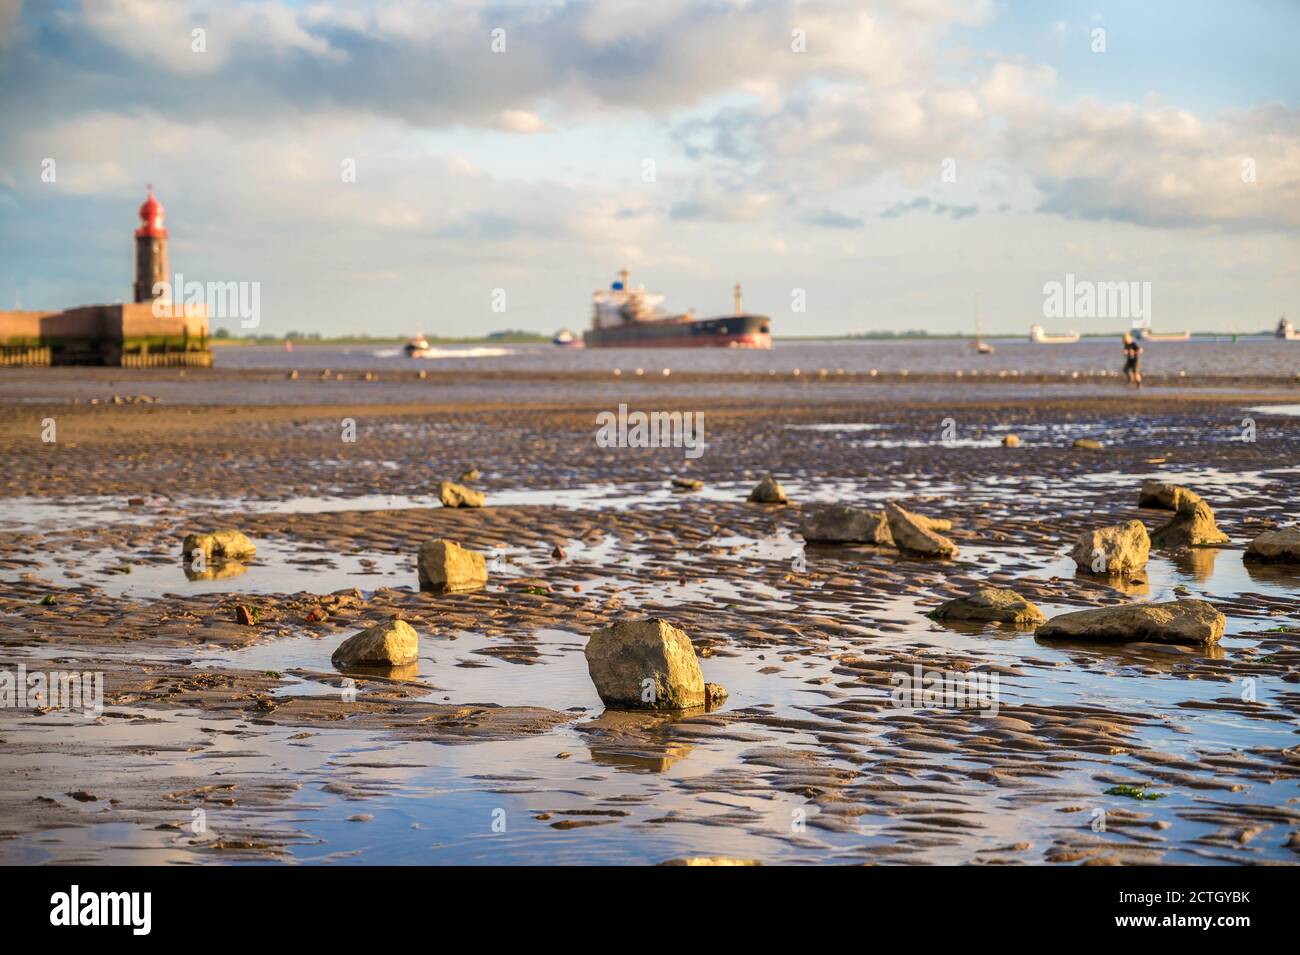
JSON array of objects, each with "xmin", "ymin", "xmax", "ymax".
[{"xmin": 1036, "ymin": 600, "xmax": 1227, "ymax": 647}]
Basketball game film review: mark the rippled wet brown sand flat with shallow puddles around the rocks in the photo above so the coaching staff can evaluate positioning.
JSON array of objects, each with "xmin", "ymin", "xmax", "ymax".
[{"xmin": 0, "ymin": 369, "xmax": 1300, "ymax": 864}]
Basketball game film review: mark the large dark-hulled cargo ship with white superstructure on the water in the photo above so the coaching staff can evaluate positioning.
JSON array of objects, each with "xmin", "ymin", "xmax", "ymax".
[{"xmin": 582, "ymin": 269, "xmax": 772, "ymax": 348}]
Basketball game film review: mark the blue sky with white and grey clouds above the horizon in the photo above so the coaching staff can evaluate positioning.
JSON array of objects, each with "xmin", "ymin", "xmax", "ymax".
[{"xmin": 0, "ymin": 0, "xmax": 1300, "ymax": 337}]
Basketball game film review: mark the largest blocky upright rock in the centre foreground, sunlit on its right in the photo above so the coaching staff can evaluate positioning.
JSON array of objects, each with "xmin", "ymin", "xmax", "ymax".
[{"xmin": 584, "ymin": 618, "xmax": 705, "ymax": 709}]
